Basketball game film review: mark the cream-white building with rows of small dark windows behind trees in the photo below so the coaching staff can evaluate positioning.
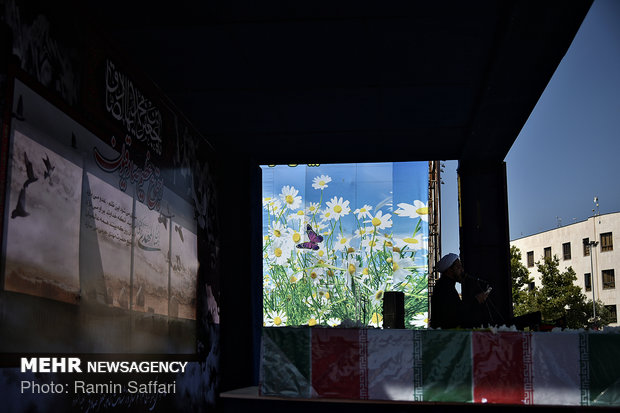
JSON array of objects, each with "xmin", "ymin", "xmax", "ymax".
[{"xmin": 510, "ymin": 212, "xmax": 620, "ymax": 326}]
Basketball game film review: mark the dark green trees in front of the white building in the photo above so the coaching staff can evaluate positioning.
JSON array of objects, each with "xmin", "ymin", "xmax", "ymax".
[{"xmin": 510, "ymin": 246, "xmax": 612, "ymax": 328}]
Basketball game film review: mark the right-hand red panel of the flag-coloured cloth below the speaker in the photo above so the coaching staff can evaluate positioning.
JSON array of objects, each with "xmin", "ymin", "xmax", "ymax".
[{"xmin": 472, "ymin": 332, "xmax": 525, "ymax": 404}]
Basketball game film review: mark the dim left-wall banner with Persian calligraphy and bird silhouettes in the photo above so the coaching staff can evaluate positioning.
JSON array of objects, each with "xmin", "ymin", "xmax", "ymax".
[{"xmin": 0, "ymin": 80, "xmax": 199, "ymax": 352}]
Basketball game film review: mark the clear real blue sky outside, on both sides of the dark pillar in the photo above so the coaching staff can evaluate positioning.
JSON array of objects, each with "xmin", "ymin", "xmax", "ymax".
[{"xmin": 442, "ymin": 0, "xmax": 620, "ymax": 254}]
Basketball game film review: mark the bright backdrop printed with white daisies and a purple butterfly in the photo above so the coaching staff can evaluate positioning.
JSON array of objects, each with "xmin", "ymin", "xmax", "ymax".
[{"xmin": 262, "ymin": 162, "xmax": 429, "ymax": 328}]
